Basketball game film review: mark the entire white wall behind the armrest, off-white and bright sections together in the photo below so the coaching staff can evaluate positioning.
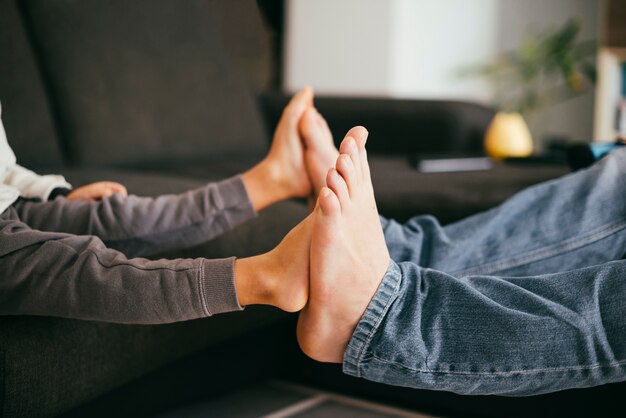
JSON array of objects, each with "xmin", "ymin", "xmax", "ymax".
[{"xmin": 284, "ymin": 0, "xmax": 498, "ymax": 98}]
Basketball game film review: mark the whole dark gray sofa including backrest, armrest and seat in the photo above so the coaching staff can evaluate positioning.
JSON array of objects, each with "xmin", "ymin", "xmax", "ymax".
[{"xmin": 0, "ymin": 0, "xmax": 620, "ymax": 417}]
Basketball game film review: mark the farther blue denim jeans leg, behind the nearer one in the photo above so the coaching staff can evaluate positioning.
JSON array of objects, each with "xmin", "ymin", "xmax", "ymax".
[{"xmin": 382, "ymin": 144, "xmax": 626, "ymax": 276}]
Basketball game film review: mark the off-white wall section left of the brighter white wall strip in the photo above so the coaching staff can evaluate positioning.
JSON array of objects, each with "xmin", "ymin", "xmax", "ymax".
[{"xmin": 283, "ymin": 0, "xmax": 391, "ymax": 95}]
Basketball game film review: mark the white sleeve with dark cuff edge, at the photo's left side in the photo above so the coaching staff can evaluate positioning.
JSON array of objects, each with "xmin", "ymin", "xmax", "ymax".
[{"xmin": 4, "ymin": 164, "xmax": 72, "ymax": 201}]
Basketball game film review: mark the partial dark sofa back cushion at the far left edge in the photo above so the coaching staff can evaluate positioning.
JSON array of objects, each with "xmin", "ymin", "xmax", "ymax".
[{"xmin": 0, "ymin": 0, "xmax": 63, "ymax": 168}]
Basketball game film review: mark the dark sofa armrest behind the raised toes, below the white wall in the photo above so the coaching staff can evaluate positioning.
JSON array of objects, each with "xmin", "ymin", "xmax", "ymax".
[{"xmin": 260, "ymin": 91, "xmax": 495, "ymax": 155}]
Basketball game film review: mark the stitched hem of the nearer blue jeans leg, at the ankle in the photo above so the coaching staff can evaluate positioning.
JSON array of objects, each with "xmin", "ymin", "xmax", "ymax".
[{"xmin": 343, "ymin": 260, "xmax": 402, "ymax": 377}]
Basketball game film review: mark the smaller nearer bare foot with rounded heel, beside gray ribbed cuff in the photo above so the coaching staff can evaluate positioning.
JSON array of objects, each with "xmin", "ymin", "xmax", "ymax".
[{"xmin": 235, "ymin": 215, "xmax": 313, "ymax": 312}]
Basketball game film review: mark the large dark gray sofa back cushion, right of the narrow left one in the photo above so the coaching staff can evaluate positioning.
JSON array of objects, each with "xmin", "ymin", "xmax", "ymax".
[{"xmin": 22, "ymin": 0, "xmax": 266, "ymax": 167}]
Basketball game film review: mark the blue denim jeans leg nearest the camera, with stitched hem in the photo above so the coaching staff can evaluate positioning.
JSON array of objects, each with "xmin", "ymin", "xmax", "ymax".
[{"xmin": 343, "ymin": 261, "xmax": 626, "ymax": 396}]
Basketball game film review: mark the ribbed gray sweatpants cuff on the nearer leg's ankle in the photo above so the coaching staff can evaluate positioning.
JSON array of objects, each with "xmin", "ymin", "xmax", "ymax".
[{"xmin": 199, "ymin": 257, "xmax": 243, "ymax": 316}]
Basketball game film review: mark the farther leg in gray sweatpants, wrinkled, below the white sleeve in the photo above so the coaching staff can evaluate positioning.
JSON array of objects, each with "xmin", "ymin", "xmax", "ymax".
[{"xmin": 14, "ymin": 176, "xmax": 255, "ymax": 257}]
